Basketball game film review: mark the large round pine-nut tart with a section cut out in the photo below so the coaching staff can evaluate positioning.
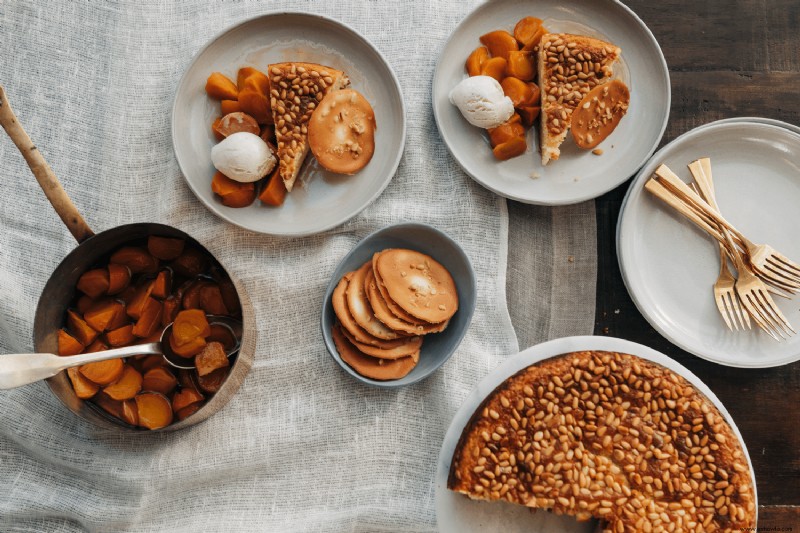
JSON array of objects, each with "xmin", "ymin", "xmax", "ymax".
[{"xmin": 447, "ymin": 351, "xmax": 756, "ymax": 533}]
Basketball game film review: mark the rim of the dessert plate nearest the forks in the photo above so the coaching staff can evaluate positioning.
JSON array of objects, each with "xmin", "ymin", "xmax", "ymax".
[{"xmin": 431, "ymin": 0, "xmax": 672, "ymax": 206}]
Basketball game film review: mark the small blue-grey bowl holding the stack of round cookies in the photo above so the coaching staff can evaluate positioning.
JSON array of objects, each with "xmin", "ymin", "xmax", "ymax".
[{"xmin": 322, "ymin": 223, "xmax": 477, "ymax": 389}]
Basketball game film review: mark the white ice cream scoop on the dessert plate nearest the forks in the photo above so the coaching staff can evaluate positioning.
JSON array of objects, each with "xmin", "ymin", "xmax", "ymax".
[{"xmin": 450, "ymin": 76, "xmax": 514, "ymax": 129}]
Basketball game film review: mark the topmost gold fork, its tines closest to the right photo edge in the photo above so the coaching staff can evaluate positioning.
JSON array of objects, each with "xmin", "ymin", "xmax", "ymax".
[{"xmin": 655, "ymin": 165, "xmax": 800, "ymax": 293}]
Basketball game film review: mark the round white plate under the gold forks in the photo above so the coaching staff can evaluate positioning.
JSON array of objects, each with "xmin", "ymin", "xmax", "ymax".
[{"xmin": 617, "ymin": 118, "xmax": 800, "ymax": 368}]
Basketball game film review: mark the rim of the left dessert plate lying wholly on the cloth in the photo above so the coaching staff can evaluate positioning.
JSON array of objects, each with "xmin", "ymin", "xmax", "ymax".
[{"xmin": 170, "ymin": 9, "xmax": 408, "ymax": 237}]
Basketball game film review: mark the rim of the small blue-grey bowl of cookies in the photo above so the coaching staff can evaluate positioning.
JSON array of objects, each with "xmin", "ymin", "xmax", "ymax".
[{"xmin": 320, "ymin": 222, "xmax": 477, "ymax": 389}]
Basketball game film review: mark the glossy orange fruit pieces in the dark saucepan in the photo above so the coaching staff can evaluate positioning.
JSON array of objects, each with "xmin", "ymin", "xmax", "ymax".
[{"xmin": 57, "ymin": 236, "xmax": 241, "ymax": 429}]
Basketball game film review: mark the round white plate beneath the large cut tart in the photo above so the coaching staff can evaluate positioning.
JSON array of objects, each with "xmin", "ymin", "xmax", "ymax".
[{"xmin": 436, "ymin": 336, "xmax": 758, "ymax": 533}]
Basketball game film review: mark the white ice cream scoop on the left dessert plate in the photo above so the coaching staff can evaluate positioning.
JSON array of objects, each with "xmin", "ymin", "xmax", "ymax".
[{"xmin": 211, "ymin": 131, "xmax": 277, "ymax": 183}]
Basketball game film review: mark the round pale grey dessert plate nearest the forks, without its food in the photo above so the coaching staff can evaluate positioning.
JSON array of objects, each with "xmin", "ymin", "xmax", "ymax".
[{"xmin": 433, "ymin": 0, "xmax": 670, "ymax": 205}]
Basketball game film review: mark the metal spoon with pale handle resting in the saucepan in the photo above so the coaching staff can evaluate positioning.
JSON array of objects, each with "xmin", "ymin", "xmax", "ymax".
[{"xmin": 0, "ymin": 315, "xmax": 242, "ymax": 389}]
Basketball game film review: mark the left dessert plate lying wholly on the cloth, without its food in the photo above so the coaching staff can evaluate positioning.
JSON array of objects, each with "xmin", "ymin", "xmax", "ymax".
[{"xmin": 172, "ymin": 13, "xmax": 406, "ymax": 236}]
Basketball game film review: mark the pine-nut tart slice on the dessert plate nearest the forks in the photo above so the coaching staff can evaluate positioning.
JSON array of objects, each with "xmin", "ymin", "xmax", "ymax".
[{"xmin": 538, "ymin": 33, "xmax": 622, "ymax": 165}]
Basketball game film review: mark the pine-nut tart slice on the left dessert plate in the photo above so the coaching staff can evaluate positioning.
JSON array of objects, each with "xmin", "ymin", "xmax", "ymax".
[{"xmin": 267, "ymin": 62, "xmax": 350, "ymax": 192}]
